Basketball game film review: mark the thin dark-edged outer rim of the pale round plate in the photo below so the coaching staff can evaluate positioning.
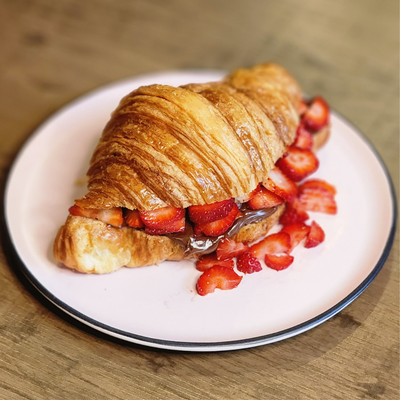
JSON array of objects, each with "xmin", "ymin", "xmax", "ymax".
[{"xmin": 3, "ymin": 69, "xmax": 398, "ymax": 352}]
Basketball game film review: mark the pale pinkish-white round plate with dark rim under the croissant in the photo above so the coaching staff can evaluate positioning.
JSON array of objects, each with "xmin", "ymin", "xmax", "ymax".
[{"xmin": 5, "ymin": 71, "xmax": 396, "ymax": 351}]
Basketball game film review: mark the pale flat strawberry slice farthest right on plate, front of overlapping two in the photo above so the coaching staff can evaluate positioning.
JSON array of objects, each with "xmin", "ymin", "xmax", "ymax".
[{"xmin": 298, "ymin": 187, "xmax": 337, "ymax": 214}]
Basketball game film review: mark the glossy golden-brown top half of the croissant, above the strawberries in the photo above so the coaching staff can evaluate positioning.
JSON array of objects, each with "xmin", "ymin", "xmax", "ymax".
[{"xmin": 75, "ymin": 64, "xmax": 301, "ymax": 211}]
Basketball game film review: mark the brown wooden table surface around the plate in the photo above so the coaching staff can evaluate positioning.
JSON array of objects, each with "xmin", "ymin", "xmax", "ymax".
[{"xmin": 0, "ymin": 0, "xmax": 399, "ymax": 400}]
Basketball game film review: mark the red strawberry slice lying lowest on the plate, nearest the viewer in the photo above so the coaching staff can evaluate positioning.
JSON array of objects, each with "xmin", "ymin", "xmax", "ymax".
[{"xmin": 196, "ymin": 265, "xmax": 242, "ymax": 296}]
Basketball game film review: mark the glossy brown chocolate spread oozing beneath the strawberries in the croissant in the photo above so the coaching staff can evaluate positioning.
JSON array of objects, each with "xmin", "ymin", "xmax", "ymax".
[{"xmin": 165, "ymin": 207, "xmax": 277, "ymax": 257}]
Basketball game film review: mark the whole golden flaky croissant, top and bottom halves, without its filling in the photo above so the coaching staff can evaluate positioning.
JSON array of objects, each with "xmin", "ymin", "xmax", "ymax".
[{"xmin": 54, "ymin": 63, "xmax": 329, "ymax": 273}]
